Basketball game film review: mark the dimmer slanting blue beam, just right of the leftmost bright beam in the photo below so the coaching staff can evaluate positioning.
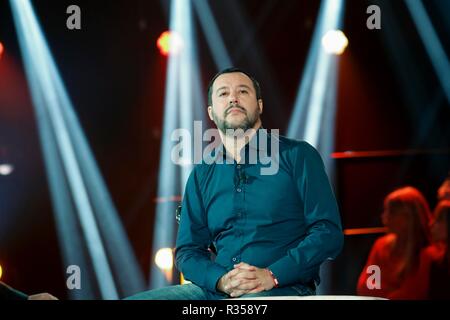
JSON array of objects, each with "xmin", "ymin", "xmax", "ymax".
[{"xmin": 45, "ymin": 31, "xmax": 145, "ymax": 296}]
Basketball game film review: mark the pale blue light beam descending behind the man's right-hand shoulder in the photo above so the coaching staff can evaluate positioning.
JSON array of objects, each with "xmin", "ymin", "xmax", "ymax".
[{"xmin": 288, "ymin": 0, "xmax": 344, "ymax": 294}]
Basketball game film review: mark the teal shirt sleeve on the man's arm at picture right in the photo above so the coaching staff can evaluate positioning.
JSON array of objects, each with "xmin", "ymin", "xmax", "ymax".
[{"xmin": 268, "ymin": 142, "xmax": 344, "ymax": 286}]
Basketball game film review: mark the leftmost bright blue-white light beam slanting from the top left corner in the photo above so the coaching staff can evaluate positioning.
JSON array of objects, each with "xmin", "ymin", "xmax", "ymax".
[{"xmin": 10, "ymin": 0, "xmax": 118, "ymax": 299}]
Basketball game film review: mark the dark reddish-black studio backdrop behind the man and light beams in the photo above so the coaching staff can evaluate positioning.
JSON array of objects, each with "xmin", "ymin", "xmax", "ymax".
[{"xmin": 0, "ymin": 0, "xmax": 450, "ymax": 298}]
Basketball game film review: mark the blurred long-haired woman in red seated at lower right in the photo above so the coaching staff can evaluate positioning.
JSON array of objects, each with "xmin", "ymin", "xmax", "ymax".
[{"xmin": 357, "ymin": 187, "xmax": 431, "ymax": 299}]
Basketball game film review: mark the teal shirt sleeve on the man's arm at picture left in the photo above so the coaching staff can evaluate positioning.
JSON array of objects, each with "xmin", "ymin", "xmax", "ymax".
[{"xmin": 175, "ymin": 167, "xmax": 227, "ymax": 292}]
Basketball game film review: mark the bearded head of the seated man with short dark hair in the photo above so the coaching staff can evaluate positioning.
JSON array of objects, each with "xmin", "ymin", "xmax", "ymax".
[{"xmin": 208, "ymin": 72, "xmax": 263, "ymax": 133}]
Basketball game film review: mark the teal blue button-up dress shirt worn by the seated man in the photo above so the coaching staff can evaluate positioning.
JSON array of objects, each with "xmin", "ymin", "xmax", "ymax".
[{"xmin": 175, "ymin": 129, "xmax": 343, "ymax": 298}]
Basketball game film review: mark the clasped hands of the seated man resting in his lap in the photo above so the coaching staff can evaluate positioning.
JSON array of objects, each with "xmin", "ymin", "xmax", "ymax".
[{"xmin": 217, "ymin": 262, "xmax": 275, "ymax": 298}]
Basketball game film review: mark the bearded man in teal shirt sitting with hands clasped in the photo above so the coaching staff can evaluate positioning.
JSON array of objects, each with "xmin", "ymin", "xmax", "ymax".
[{"xmin": 131, "ymin": 68, "xmax": 343, "ymax": 299}]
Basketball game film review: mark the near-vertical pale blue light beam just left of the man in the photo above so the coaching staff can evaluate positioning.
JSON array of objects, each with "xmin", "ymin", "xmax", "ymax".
[{"xmin": 150, "ymin": 0, "xmax": 206, "ymax": 288}]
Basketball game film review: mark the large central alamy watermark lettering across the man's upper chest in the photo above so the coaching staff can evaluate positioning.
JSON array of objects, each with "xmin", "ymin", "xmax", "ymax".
[{"xmin": 170, "ymin": 121, "xmax": 279, "ymax": 175}]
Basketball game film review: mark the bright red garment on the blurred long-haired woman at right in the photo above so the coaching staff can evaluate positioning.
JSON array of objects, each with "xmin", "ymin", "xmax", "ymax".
[{"xmin": 357, "ymin": 234, "xmax": 435, "ymax": 300}]
